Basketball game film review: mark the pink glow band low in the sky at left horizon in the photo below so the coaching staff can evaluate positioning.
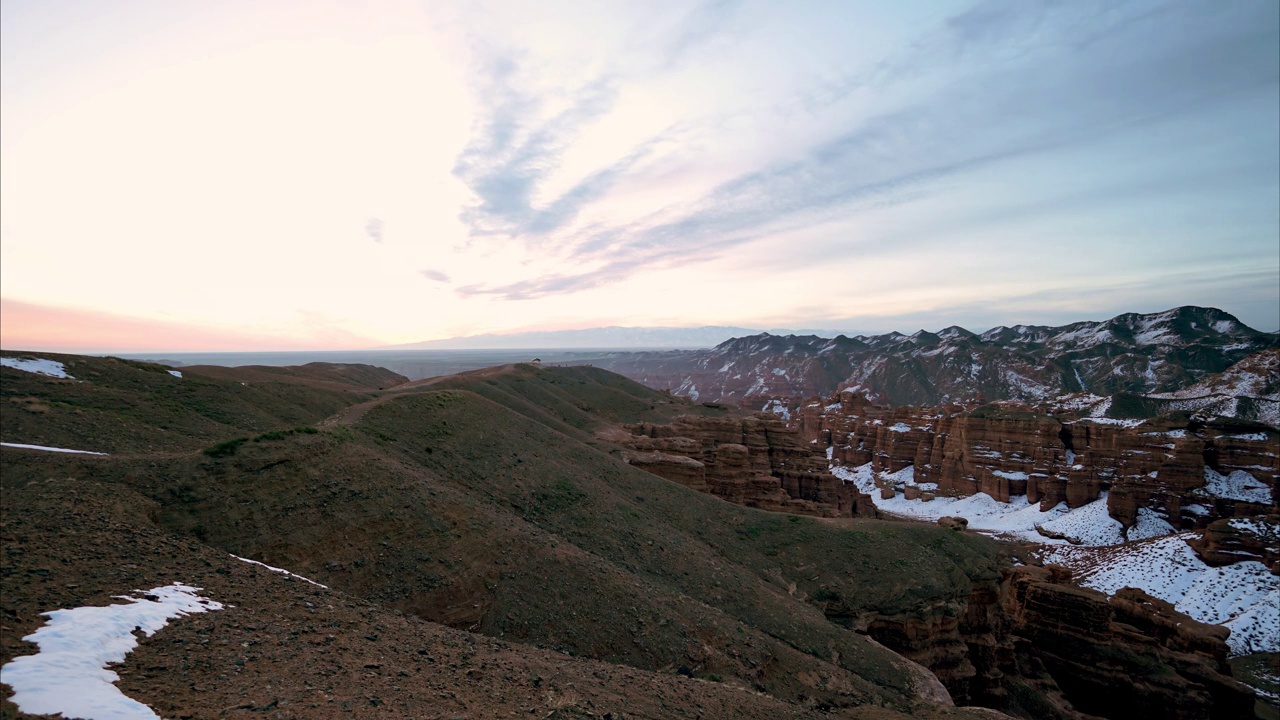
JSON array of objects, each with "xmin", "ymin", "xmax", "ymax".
[{"xmin": 0, "ymin": 299, "xmax": 379, "ymax": 352}]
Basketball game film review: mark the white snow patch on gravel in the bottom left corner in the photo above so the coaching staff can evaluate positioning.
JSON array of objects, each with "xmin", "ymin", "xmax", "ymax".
[{"xmin": 0, "ymin": 583, "xmax": 223, "ymax": 720}]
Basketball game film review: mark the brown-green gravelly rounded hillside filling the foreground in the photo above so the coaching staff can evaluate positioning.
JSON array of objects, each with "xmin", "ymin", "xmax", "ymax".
[{"xmin": 0, "ymin": 356, "xmax": 1252, "ymax": 717}]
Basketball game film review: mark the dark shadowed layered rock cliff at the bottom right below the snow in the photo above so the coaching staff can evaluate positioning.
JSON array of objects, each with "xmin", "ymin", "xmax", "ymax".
[{"xmin": 844, "ymin": 566, "xmax": 1253, "ymax": 720}]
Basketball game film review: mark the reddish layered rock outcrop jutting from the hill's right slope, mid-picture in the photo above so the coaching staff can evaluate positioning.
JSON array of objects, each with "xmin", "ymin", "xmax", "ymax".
[{"xmin": 605, "ymin": 414, "xmax": 876, "ymax": 516}]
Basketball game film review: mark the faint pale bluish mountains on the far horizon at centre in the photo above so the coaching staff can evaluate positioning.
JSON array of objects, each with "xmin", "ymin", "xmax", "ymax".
[{"xmin": 384, "ymin": 325, "xmax": 849, "ymax": 350}]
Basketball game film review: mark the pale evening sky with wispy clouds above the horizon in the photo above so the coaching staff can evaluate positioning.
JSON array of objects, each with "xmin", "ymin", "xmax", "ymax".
[{"xmin": 0, "ymin": 0, "xmax": 1280, "ymax": 351}]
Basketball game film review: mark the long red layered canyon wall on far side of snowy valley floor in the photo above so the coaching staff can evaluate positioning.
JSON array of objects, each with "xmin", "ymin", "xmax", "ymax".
[{"xmin": 792, "ymin": 391, "xmax": 1280, "ymax": 529}]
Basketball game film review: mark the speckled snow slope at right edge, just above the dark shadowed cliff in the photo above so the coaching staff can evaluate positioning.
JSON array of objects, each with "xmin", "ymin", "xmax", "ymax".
[{"xmin": 1044, "ymin": 533, "xmax": 1280, "ymax": 656}]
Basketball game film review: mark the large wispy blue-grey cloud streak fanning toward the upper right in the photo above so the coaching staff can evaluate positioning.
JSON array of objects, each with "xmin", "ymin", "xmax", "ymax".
[{"xmin": 445, "ymin": 1, "xmax": 1280, "ymax": 300}]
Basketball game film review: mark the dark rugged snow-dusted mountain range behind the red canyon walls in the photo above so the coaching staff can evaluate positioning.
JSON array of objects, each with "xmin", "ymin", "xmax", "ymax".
[{"xmin": 594, "ymin": 306, "xmax": 1280, "ymax": 405}]
